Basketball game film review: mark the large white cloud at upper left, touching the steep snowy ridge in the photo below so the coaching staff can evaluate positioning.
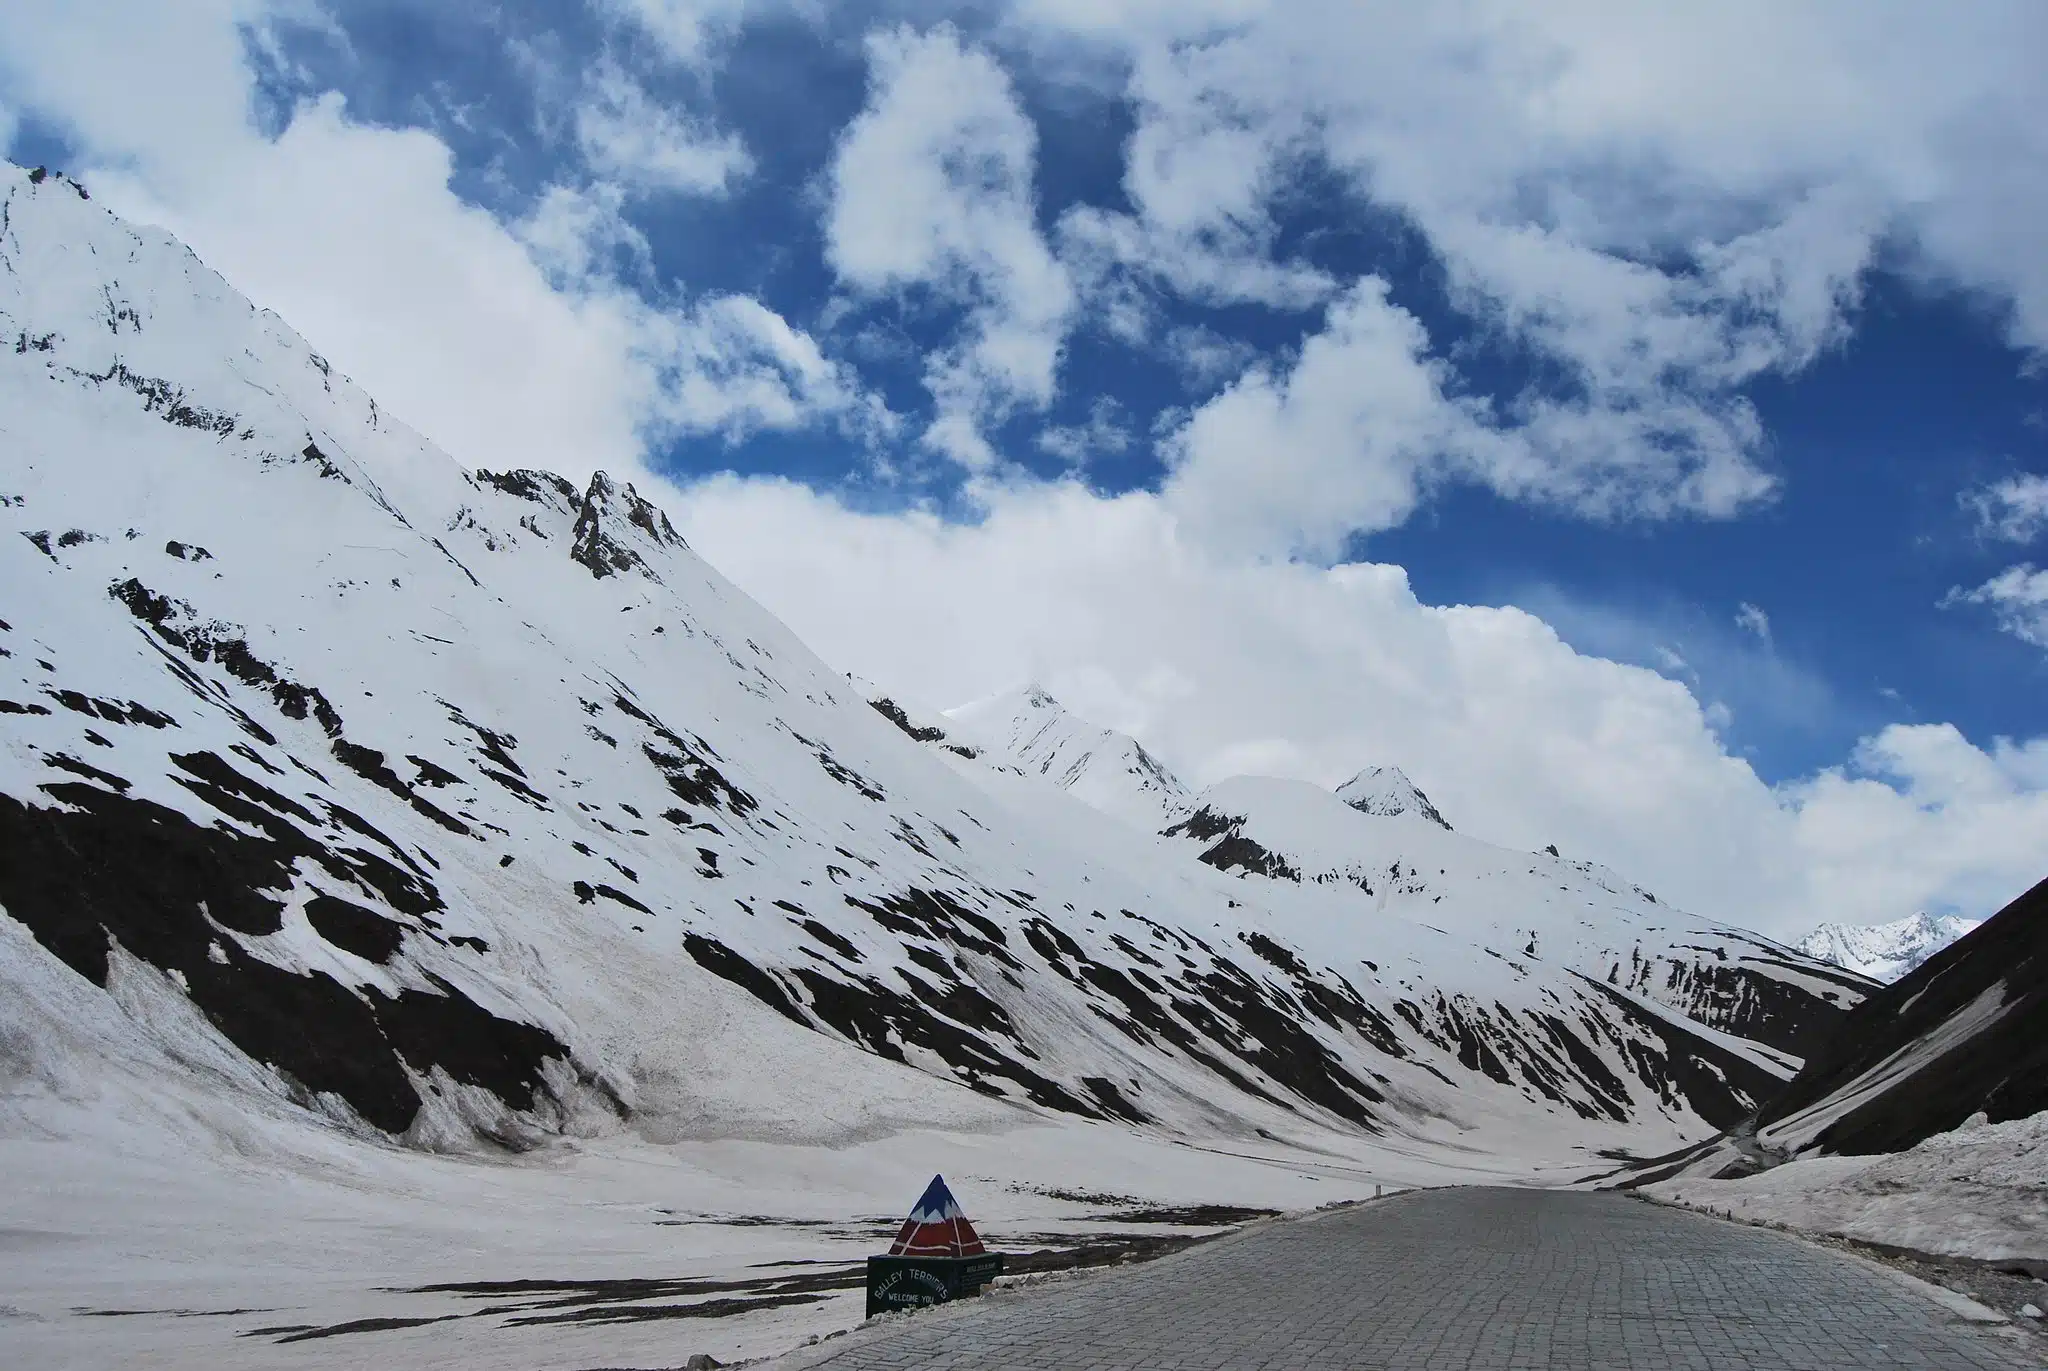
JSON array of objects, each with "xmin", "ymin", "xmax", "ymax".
[{"xmin": 0, "ymin": 0, "xmax": 877, "ymax": 475}]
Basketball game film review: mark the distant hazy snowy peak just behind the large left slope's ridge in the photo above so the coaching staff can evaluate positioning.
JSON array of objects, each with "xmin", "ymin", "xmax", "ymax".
[{"xmin": 946, "ymin": 684, "xmax": 1192, "ymax": 832}]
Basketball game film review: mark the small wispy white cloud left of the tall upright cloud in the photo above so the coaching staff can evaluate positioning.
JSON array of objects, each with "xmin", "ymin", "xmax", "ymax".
[{"xmin": 573, "ymin": 61, "xmax": 754, "ymax": 195}]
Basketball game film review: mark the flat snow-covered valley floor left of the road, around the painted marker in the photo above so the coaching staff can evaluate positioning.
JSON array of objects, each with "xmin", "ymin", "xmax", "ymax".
[{"xmin": 0, "ymin": 1115, "xmax": 1585, "ymax": 1371}]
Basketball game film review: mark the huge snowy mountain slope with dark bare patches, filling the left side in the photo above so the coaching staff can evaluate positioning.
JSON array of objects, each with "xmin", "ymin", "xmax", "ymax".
[{"xmin": 0, "ymin": 168, "xmax": 1855, "ymax": 1156}]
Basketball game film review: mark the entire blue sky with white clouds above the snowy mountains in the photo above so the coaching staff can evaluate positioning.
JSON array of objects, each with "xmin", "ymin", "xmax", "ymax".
[{"xmin": 0, "ymin": 0, "xmax": 2048, "ymax": 930}]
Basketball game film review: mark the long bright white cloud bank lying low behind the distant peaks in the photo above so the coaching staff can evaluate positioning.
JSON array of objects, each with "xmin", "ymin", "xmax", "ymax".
[{"xmin": 678, "ymin": 477, "xmax": 2048, "ymax": 934}]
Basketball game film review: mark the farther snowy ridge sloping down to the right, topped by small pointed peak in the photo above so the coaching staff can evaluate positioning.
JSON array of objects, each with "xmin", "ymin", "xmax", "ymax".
[{"xmin": 1167, "ymin": 777, "xmax": 1872, "ymax": 1066}]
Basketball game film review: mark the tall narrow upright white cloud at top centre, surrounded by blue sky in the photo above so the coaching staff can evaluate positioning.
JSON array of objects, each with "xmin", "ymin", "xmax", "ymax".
[{"xmin": 825, "ymin": 25, "xmax": 1073, "ymax": 471}]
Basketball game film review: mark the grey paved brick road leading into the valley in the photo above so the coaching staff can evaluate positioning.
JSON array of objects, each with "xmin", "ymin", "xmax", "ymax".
[{"xmin": 807, "ymin": 1189, "xmax": 2040, "ymax": 1371}]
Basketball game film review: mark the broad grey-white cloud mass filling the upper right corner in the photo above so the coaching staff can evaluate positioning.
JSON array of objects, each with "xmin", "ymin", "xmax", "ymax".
[{"xmin": 1012, "ymin": 0, "xmax": 2048, "ymax": 543}]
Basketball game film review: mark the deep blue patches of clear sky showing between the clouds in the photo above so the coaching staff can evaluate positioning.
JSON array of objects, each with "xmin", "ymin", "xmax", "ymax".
[{"xmin": 148, "ymin": 4, "xmax": 2048, "ymax": 781}]
